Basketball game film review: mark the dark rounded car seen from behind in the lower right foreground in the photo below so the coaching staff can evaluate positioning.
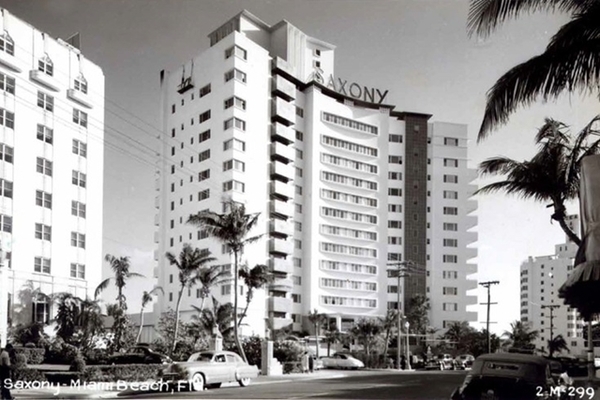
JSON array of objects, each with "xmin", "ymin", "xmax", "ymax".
[{"xmin": 450, "ymin": 353, "xmax": 557, "ymax": 400}]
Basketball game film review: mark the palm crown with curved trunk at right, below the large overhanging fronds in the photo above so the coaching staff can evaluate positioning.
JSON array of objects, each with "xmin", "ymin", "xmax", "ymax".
[{"xmin": 475, "ymin": 117, "xmax": 600, "ymax": 245}]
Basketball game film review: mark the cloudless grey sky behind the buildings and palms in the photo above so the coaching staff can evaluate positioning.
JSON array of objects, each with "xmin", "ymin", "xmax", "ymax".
[{"xmin": 0, "ymin": 0, "xmax": 599, "ymax": 333}]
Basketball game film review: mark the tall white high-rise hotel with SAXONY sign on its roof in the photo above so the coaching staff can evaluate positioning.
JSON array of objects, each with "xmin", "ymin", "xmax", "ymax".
[{"xmin": 154, "ymin": 11, "xmax": 477, "ymax": 335}]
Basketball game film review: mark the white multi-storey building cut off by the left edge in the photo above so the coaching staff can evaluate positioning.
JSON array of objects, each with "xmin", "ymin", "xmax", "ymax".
[{"xmin": 0, "ymin": 9, "xmax": 104, "ymax": 340}]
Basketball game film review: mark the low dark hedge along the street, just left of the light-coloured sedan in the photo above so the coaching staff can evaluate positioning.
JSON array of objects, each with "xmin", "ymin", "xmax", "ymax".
[{"xmin": 83, "ymin": 364, "xmax": 165, "ymax": 382}]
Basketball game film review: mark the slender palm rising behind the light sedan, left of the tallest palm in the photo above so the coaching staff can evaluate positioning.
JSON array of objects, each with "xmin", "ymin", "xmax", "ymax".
[{"xmin": 166, "ymin": 243, "xmax": 215, "ymax": 354}]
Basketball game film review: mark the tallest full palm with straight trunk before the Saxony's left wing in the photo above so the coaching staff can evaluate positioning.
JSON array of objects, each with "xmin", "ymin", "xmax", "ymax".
[{"xmin": 188, "ymin": 200, "xmax": 260, "ymax": 362}]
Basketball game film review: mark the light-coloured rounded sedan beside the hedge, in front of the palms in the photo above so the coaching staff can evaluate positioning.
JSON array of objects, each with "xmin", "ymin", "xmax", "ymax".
[{"xmin": 160, "ymin": 351, "xmax": 258, "ymax": 391}]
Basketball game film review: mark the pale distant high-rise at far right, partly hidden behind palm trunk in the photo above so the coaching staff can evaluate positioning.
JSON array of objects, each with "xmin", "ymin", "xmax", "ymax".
[{"xmin": 521, "ymin": 215, "xmax": 586, "ymax": 355}]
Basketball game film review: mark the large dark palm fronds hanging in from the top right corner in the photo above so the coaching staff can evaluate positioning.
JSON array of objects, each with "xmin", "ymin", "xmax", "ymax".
[{"xmin": 468, "ymin": 0, "xmax": 600, "ymax": 140}]
